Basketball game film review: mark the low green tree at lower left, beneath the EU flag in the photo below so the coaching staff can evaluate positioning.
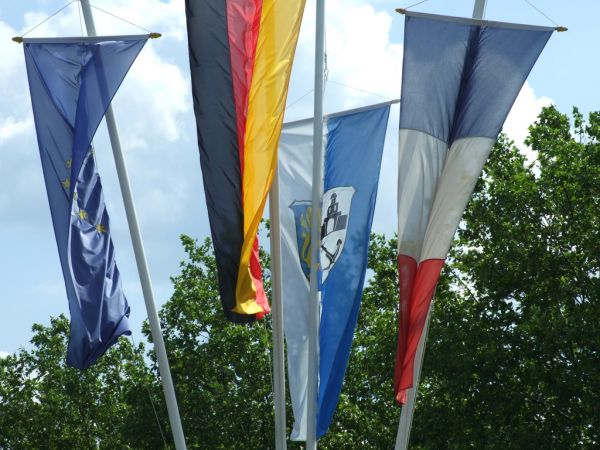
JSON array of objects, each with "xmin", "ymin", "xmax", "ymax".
[{"xmin": 0, "ymin": 316, "xmax": 163, "ymax": 450}]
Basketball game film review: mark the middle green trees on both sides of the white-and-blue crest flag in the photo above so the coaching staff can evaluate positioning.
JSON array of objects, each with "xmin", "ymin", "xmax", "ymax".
[{"xmin": 150, "ymin": 232, "xmax": 400, "ymax": 449}]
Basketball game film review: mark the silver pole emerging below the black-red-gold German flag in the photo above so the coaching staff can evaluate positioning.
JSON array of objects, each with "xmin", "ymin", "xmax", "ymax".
[{"xmin": 269, "ymin": 168, "xmax": 287, "ymax": 450}]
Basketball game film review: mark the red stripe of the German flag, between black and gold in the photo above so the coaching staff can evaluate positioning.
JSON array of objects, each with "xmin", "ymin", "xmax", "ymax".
[{"xmin": 227, "ymin": 0, "xmax": 270, "ymax": 318}]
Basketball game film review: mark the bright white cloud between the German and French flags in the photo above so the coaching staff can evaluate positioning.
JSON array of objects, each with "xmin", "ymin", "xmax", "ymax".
[{"xmin": 286, "ymin": 0, "xmax": 402, "ymax": 120}]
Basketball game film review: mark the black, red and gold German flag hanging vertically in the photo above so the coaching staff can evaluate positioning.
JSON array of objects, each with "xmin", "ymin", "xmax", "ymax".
[{"xmin": 186, "ymin": 0, "xmax": 305, "ymax": 323}]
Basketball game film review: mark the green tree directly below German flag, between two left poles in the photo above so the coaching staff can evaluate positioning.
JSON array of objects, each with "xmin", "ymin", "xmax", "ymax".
[{"xmin": 150, "ymin": 236, "xmax": 274, "ymax": 449}]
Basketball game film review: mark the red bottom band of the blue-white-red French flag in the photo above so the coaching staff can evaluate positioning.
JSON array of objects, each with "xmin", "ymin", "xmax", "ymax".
[{"xmin": 394, "ymin": 255, "xmax": 444, "ymax": 404}]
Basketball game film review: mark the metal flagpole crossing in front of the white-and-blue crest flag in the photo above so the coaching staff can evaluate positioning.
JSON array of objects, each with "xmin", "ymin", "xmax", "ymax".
[{"xmin": 306, "ymin": 0, "xmax": 325, "ymax": 444}]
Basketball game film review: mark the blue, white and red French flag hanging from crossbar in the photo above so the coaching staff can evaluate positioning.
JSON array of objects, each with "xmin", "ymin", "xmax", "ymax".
[{"xmin": 394, "ymin": 13, "xmax": 554, "ymax": 403}]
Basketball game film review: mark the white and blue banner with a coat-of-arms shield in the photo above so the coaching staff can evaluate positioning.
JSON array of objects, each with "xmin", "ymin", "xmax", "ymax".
[{"xmin": 279, "ymin": 103, "xmax": 390, "ymax": 440}]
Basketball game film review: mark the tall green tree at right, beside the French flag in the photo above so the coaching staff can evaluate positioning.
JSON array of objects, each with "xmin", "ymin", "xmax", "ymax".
[{"xmin": 412, "ymin": 107, "xmax": 600, "ymax": 449}]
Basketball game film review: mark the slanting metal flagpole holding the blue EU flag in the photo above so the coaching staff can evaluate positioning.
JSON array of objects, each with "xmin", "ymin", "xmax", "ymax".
[{"xmin": 81, "ymin": 0, "xmax": 186, "ymax": 450}]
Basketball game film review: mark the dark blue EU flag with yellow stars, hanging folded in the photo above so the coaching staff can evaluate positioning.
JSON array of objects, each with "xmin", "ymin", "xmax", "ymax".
[{"xmin": 23, "ymin": 36, "xmax": 148, "ymax": 369}]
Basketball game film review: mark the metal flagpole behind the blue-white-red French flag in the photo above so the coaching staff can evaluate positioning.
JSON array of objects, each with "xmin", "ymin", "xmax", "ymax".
[{"xmin": 395, "ymin": 0, "xmax": 487, "ymax": 450}]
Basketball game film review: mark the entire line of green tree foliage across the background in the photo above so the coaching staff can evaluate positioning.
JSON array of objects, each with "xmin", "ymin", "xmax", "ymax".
[{"xmin": 0, "ymin": 107, "xmax": 600, "ymax": 450}]
